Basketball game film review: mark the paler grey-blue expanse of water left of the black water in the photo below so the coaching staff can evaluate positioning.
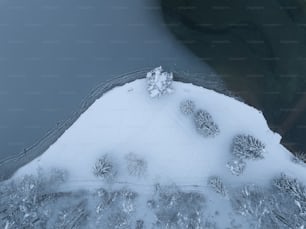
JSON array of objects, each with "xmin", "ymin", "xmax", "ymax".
[{"xmin": 0, "ymin": 0, "xmax": 225, "ymax": 178}]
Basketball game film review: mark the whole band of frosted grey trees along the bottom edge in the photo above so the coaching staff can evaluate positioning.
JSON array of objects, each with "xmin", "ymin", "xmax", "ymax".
[{"xmin": 0, "ymin": 167, "xmax": 306, "ymax": 229}]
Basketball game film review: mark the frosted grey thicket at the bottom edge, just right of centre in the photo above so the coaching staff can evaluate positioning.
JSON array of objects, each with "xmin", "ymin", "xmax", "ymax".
[{"xmin": 148, "ymin": 185, "xmax": 205, "ymax": 229}]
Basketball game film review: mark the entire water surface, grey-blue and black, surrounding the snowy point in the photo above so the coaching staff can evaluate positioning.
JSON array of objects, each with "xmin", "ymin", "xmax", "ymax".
[{"xmin": 0, "ymin": 0, "xmax": 306, "ymax": 178}]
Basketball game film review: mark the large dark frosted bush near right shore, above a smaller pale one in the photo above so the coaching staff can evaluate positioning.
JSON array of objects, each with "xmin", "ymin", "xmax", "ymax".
[{"xmin": 232, "ymin": 134, "xmax": 265, "ymax": 160}]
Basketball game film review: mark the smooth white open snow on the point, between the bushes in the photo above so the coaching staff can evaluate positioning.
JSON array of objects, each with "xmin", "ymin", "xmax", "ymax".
[{"xmin": 13, "ymin": 79, "xmax": 306, "ymax": 191}]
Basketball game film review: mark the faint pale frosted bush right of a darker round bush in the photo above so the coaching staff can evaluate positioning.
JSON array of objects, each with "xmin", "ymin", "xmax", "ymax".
[{"xmin": 125, "ymin": 153, "xmax": 147, "ymax": 177}]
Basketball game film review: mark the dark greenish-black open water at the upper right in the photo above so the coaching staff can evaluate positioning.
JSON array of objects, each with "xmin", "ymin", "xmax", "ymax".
[{"xmin": 161, "ymin": 0, "xmax": 306, "ymax": 155}]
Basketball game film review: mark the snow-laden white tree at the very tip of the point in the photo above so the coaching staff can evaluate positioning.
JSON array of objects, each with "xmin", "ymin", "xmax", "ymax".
[{"xmin": 146, "ymin": 67, "xmax": 173, "ymax": 98}]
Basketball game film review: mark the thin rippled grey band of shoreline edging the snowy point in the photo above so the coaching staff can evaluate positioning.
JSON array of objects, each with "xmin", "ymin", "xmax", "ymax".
[{"xmin": 0, "ymin": 68, "xmax": 227, "ymax": 181}]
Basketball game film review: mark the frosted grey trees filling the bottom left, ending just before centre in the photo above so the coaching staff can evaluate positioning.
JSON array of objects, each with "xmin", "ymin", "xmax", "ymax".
[{"xmin": 0, "ymin": 172, "xmax": 142, "ymax": 229}]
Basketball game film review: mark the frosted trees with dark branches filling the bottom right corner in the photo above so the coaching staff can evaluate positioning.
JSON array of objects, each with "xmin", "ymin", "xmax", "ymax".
[{"xmin": 230, "ymin": 174, "xmax": 306, "ymax": 229}]
